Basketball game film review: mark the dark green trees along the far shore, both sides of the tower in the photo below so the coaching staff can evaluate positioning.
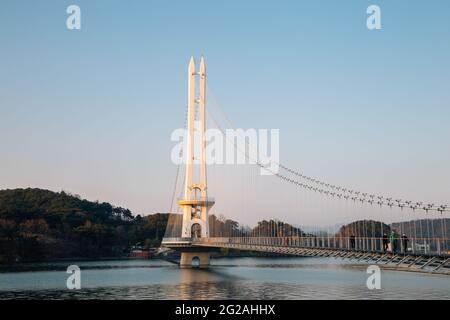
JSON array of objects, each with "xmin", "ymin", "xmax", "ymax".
[{"xmin": 0, "ymin": 188, "xmax": 450, "ymax": 265}]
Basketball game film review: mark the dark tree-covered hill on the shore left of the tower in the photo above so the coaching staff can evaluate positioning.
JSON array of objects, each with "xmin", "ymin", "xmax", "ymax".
[{"xmin": 0, "ymin": 188, "xmax": 168, "ymax": 262}]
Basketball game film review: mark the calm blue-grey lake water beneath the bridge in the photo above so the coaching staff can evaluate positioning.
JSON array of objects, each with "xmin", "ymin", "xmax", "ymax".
[{"xmin": 0, "ymin": 258, "xmax": 450, "ymax": 299}]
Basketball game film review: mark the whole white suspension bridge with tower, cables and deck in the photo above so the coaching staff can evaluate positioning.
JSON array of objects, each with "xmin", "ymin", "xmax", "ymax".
[{"xmin": 162, "ymin": 57, "xmax": 450, "ymax": 273}]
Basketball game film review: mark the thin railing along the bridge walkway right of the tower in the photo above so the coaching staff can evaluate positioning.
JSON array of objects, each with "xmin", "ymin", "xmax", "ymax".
[{"xmin": 193, "ymin": 236, "xmax": 449, "ymax": 256}]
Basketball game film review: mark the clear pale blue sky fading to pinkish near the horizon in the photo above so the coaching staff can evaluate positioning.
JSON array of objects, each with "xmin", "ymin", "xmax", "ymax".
[{"xmin": 0, "ymin": 0, "xmax": 450, "ymax": 224}]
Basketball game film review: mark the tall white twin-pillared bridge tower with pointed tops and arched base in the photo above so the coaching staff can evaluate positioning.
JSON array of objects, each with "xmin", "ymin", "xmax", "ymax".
[{"xmin": 177, "ymin": 57, "xmax": 214, "ymax": 267}]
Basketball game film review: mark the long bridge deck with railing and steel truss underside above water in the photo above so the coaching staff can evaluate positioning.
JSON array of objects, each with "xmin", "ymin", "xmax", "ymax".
[{"xmin": 162, "ymin": 237, "xmax": 450, "ymax": 274}]
